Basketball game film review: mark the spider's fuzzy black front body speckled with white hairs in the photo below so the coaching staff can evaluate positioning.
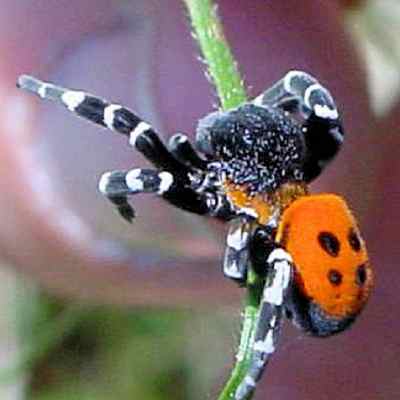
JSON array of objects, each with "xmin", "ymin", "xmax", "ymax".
[{"xmin": 196, "ymin": 104, "xmax": 306, "ymax": 194}]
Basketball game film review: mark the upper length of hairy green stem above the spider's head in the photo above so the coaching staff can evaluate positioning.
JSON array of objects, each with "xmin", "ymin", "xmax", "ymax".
[{"xmin": 183, "ymin": 0, "xmax": 246, "ymax": 110}]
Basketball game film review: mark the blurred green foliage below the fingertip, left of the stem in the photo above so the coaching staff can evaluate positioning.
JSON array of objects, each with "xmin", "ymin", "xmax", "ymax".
[{"xmin": 7, "ymin": 284, "xmax": 235, "ymax": 400}]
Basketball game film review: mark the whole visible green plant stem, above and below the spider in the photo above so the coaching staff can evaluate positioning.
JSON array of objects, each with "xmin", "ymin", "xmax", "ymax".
[{"xmin": 183, "ymin": 0, "xmax": 262, "ymax": 400}]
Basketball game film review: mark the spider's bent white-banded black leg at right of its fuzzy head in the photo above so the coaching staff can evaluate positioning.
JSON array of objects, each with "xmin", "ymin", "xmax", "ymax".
[{"xmin": 254, "ymin": 71, "xmax": 344, "ymax": 181}]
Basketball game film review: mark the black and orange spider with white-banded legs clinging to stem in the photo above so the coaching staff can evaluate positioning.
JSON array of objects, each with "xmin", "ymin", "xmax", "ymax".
[{"xmin": 18, "ymin": 71, "xmax": 373, "ymax": 400}]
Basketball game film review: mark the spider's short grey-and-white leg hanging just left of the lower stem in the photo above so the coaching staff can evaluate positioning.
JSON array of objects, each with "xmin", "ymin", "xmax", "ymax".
[{"xmin": 223, "ymin": 218, "xmax": 253, "ymax": 284}]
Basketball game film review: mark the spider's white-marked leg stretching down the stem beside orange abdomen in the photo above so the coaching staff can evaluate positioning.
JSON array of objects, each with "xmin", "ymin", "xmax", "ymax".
[{"xmin": 235, "ymin": 248, "xmax": 293, "ymax": 400}]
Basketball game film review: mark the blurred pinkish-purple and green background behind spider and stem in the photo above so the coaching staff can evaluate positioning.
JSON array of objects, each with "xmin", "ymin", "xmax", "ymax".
[{"xmin": 0, "ymin": 0, "xmax": 400, "ymax": 400}]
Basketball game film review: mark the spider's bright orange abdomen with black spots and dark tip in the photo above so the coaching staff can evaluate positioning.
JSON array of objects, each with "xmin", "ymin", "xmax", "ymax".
[{"xmin": 277, "ymin": 194, "xmax": 373, "ymax": 336}]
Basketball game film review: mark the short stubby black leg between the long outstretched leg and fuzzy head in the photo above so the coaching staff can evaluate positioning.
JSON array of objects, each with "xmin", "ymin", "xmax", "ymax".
[{"xmin": 168, "ymin": 133, "xmax": 208, "ymax": 171}]
